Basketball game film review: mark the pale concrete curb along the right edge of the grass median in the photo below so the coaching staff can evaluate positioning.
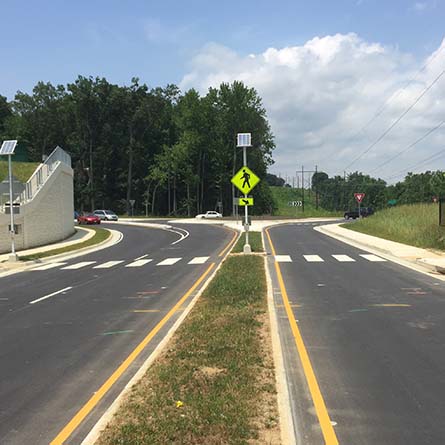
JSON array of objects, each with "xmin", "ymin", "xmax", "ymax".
[{"xmin": 261, "ymin": 230, "xmax": 296, "ymax": 445}]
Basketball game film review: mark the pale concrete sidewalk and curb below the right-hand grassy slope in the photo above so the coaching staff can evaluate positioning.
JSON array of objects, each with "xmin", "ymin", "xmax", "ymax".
[{"xmin": 314, "ymin": 224, "xmax": 445, "ymax": 281}]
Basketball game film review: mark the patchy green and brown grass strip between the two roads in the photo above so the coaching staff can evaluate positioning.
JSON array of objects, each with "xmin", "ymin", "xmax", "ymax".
[{"xmin": 97, "ymin": 256, "xmax": 280, "ymax": 445}]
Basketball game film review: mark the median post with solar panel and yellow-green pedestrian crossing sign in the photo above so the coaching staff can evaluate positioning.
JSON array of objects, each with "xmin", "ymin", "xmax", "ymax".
[{"xmin": 232, "ymin": 133, "xmax": 260, "ymax": 253}]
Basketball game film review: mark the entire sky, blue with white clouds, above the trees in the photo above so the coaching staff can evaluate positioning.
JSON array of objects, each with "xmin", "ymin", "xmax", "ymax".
[{"xmin": 0, "ymin": 0, "xmax": 445, "ymax": 183}]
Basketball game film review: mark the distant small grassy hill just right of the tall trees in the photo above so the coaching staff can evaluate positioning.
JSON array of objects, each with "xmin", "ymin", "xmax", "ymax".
[{"xmin": 270, "ymin": 186, "xmax": 340, "ymax": 218}]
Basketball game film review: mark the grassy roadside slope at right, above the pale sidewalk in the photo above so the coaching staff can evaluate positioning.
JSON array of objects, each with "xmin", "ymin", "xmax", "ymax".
[{"xmin": 343, "ymin": 204, "xmax": 445, "ymax": 250}]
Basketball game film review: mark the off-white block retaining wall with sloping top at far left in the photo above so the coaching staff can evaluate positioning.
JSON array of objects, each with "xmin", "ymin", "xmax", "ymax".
[{"xmin": 0, "ymin": 163, "xmax": 74, "ymax": 253}]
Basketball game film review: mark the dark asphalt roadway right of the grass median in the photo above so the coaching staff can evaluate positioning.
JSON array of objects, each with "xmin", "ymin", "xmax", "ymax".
[{"xmin": 269, "ymin": 225, "xmax": 445, "ymax": 445}]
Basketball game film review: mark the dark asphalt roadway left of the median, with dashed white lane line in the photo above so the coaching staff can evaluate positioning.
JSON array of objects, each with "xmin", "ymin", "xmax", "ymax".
[{"xmin": 0, "ymin": 224, "xmax": 233, "ymax": 445}]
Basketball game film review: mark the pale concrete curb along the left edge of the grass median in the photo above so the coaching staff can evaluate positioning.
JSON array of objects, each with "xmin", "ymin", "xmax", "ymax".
[{"xmin": 80, "ymin": 229, "xmax": 236, "ymax": 445}]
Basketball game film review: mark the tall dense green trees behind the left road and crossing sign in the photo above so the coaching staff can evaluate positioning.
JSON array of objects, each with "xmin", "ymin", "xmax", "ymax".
[{"xmin": 0, "ymin": 76, "xmax": 275, "ymax": 216}]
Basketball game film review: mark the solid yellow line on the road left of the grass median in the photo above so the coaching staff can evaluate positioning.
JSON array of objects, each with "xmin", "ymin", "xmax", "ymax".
[{"xmin": 50, "ymin": 263, "xmax": 215, "ymax": 445}]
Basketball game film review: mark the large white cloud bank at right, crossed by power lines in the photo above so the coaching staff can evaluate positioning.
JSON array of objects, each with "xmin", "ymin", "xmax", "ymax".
[{"xmin": 181, "ymin": 33, "xmax": 445, "ymax": 182}]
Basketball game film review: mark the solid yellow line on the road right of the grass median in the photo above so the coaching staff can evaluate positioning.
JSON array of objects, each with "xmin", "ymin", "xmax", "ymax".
[{"xmin": 266, "ymin": 229, "xmax": 338, "ymax": 445}]
